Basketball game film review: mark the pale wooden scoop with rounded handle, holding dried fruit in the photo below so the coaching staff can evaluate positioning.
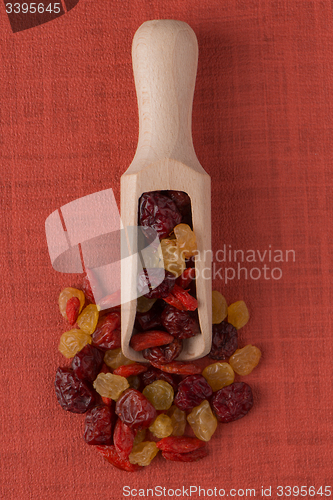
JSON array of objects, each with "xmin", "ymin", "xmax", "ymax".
[{"xmin": 121, "ymin": 20, "xmax": 212, "ymax": 361}]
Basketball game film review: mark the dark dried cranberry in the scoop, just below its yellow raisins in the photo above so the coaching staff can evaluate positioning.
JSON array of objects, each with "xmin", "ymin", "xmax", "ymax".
[{"xmin": 138, "ymin": 268, "xmax": 176, "ymax": 299}]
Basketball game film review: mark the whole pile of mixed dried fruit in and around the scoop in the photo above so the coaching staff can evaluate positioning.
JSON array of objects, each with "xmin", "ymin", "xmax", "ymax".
[{"xmin": 55, "ymin": 191, "xmax": 261, "ymax": 472}]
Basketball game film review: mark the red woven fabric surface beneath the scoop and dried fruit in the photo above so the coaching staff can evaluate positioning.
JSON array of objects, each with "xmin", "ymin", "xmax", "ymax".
[{"xmin": 0, "ymin": 0, "xmax": 333, "ymax": 500}]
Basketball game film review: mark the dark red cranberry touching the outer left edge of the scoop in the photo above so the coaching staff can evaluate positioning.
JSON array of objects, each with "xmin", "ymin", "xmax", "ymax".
[{"xmin": 92, "ymin": 312, "xmax": 121, "ymax": 350}]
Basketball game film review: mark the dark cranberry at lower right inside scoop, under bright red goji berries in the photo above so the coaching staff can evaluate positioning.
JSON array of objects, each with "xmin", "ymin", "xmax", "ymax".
[{"xmin": 161, "ymin": 305, "xmax": 200, "ymax": 339}]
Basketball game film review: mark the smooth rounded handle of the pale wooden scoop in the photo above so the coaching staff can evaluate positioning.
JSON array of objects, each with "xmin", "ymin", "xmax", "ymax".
[{"xmin": 132, "ymin": 19, "xmax": 202, "ymax": 168}]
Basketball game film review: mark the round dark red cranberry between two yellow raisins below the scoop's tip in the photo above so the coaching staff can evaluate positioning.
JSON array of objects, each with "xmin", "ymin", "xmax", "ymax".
[{"xmin": 116, "ymin": 389, "xmax": 157, "ymax": 429}]
